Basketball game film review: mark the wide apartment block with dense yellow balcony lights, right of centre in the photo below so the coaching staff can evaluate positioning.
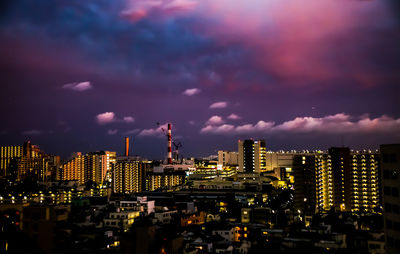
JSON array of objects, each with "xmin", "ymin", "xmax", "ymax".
[{"xmin": 293, "ymin": 147, "xmax": 382, "ymax": 212}]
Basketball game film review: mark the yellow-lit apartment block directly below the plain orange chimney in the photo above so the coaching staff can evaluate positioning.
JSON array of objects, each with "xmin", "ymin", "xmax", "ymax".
[{"xmin": 113, "ymin": 157, "xmax": 151, "ymax": 193}]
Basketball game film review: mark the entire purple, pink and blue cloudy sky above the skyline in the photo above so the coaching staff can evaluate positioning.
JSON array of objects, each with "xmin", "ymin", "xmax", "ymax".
[{"xmin": 0, "ymin": 0, "xmax": 400, "ymax": 158}]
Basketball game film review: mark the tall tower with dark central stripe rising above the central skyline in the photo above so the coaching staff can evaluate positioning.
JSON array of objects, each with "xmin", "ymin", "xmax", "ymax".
[{"xmin": 238, "ymin": 139, "xmax": 267, "ymax": 172}]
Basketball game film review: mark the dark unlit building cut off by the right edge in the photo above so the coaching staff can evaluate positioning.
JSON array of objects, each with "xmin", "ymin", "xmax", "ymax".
[{"xmin": 380, "ymin": 144, "xmax": 400, "ymax": 254}]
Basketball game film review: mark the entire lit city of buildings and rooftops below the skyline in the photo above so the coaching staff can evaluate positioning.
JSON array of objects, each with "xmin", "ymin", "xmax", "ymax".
[{"xmin": 0, "ymin": 138, "xmax": 400, "ymax": 253}]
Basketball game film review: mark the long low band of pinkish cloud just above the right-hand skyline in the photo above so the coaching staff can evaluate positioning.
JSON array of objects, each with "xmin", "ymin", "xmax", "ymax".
[{"xmin": 200, "ymin": 113, "xmax": 400, "ymax": 135}]
